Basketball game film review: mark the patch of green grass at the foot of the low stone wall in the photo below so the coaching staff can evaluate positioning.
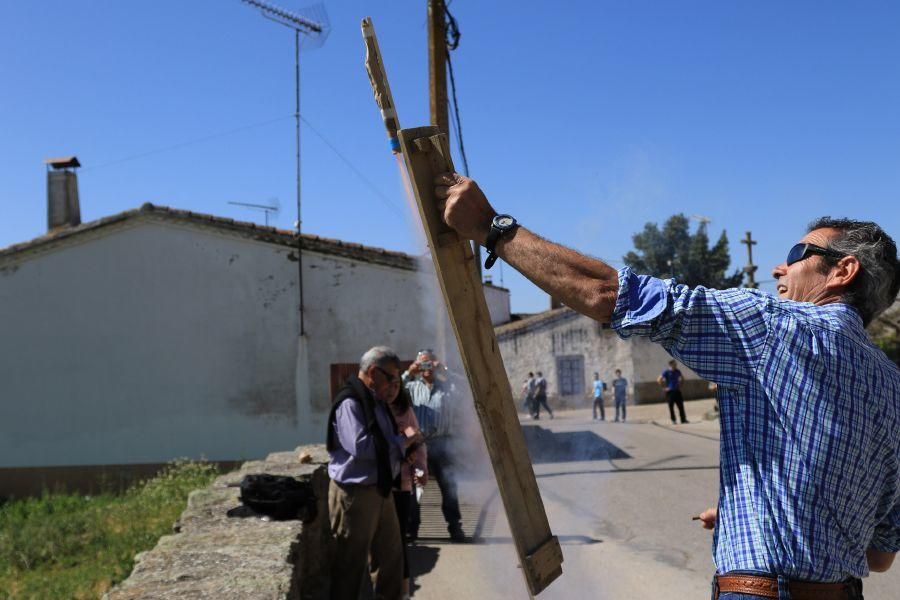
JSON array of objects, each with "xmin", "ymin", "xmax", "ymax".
[{"xmin": 0, "ymin": 461, "xmax": 218, "ymax": 600}]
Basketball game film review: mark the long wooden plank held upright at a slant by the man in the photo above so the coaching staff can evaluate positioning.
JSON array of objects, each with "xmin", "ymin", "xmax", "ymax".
[{"xmin": 399, "ymin": 127, "xmax": 563, "ymax": 595}]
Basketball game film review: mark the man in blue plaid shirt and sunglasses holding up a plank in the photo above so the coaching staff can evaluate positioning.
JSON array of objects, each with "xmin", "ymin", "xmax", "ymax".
[{"xmin": 435, "ymin": 174, "xmax": 900, "ymax": 600}]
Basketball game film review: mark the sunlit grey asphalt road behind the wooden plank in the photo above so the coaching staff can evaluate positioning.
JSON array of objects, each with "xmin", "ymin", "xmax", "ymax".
[{"xmin": 410, "ymin": 400, "xmax": 900, "ymax": 600}]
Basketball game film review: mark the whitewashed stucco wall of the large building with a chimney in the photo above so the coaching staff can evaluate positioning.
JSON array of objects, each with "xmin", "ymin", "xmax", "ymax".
[{"xmin": 0, "ymin": 219, "xmax": 442, "ymax": 467}]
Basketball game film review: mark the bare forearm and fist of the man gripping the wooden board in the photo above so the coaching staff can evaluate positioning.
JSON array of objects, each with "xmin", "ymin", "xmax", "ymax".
[{"xmin": 435, "ymin": 173, "xmax": 619, "ymax": 322}]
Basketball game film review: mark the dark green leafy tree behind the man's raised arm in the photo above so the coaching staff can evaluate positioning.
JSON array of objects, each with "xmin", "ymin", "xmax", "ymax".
[{"xmin": 623, "ymin": 213, "xmax": 743, "ymax": 289}]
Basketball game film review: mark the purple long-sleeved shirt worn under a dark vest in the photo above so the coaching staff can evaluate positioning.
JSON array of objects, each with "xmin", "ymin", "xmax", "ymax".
[{"xmin": 328, "ymin": 398, "xmax": 404, "ymax": 485}]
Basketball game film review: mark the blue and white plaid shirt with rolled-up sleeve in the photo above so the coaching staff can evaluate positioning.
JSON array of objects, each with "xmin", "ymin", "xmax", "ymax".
[{"xmin": 612, "ymin": 267, "xmax": 900, "ymax": 581}]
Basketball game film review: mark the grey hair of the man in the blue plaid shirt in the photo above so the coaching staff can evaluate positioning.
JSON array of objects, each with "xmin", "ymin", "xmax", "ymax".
[{"xmin": 808, "ymin": 217, "xmax": 900, "ymax": 326}]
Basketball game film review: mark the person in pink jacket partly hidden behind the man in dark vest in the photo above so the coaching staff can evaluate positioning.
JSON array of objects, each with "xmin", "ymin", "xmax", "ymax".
[{"xmin": 389, "ymin": 388, "xmax": 428, "ymax": 599}]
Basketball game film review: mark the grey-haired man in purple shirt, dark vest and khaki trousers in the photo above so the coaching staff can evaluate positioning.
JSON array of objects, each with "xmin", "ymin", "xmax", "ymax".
[{"xmin": 327, "ymin": 346, "xmax": 421, "ymax": 600}]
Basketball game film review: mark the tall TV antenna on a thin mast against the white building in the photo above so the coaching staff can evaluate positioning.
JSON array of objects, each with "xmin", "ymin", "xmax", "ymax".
[{"xmin": 241, "ymin": 0, "xmax": 331, "ymax": 336}]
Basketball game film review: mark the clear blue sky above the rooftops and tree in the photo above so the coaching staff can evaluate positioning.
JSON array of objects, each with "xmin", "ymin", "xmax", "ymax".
[{"xmin": 0, "ymin": 0, "xmax": 900, "ymax": 312}]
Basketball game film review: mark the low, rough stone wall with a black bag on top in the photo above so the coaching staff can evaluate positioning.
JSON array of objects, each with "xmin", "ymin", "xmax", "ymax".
[{"xmin": 104, "ymin": 445, "xmax": 332, "ymax": 600}]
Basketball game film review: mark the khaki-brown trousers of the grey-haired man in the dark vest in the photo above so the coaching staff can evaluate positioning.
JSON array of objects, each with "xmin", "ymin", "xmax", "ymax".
[{"xmin": 328, "ymin": 480, "xmax": 403, "ymax": 600}]
